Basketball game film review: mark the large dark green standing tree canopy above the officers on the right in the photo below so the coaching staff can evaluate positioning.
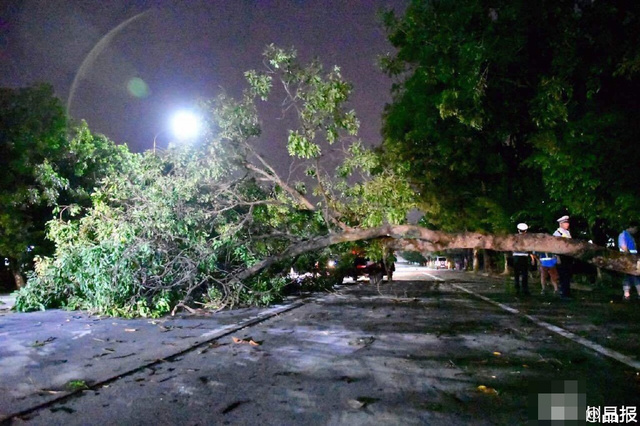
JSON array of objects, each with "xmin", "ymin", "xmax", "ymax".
[{"xmin": 383, "ymin": 0, "xmax": 640, "ymax": 240}]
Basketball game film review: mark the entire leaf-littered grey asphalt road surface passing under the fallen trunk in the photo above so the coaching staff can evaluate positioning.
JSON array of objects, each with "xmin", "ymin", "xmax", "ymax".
[{"xmin": 0, "ymin": 266, "xmax": 640, "ymax": 426}]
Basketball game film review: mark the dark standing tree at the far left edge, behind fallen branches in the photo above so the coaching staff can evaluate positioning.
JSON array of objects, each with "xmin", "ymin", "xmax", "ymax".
[{"xmin": 0, "ymin": 86, "xmax": 67, "ymax": 287}]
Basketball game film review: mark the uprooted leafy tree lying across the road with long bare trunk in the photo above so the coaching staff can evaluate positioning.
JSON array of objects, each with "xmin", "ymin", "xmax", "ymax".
[{"xmin": 16, "ymin": 46, "xmax": 638, "ymax": 316}]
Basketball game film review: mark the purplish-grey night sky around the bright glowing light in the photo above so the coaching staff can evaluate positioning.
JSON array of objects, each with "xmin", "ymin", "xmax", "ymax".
[{"xmin": 0, "ymin": 0, "xmax": 409, "ymax": 156}]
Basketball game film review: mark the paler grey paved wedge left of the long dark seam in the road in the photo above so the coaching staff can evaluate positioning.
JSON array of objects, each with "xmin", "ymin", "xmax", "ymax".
[{"xmin": 0, "ymin": 296, "xmax": 301, "ymax": 423}]
